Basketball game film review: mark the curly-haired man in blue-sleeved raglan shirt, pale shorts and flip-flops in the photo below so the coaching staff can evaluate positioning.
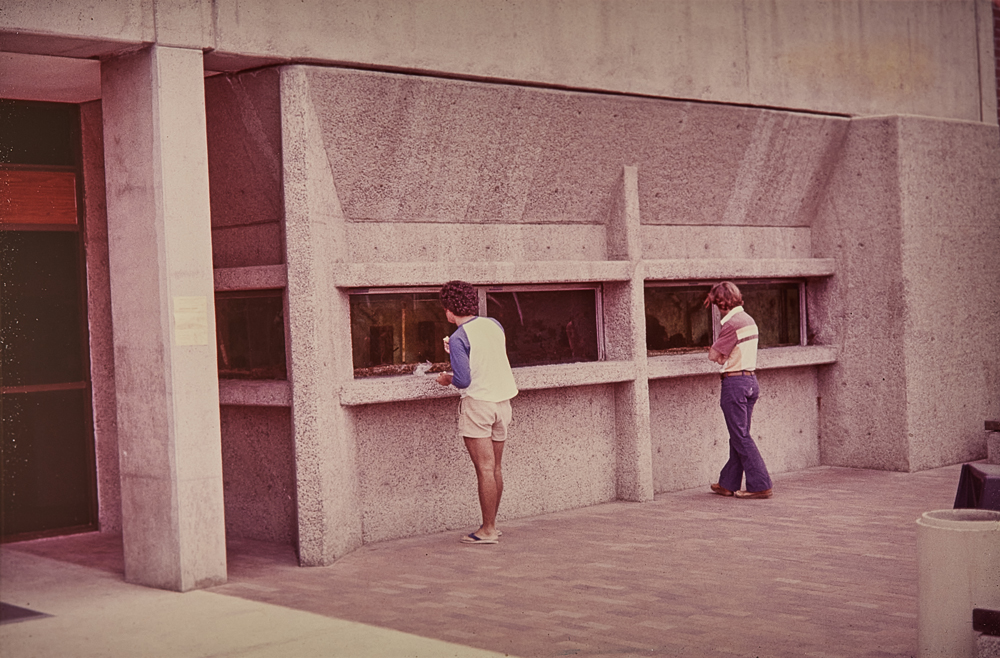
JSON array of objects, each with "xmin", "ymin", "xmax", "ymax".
[{"xmin": 437, "ymin": 281, "xmax": 517, "ymax": 544}]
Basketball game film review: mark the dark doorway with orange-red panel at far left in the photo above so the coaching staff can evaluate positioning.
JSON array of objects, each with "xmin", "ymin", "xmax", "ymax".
[{"xmin": 0, "ymin": 100, "xmax": 97, "ymax": 541}]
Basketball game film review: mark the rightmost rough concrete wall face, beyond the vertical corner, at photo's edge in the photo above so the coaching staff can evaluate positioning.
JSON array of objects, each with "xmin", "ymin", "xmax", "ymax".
[{"xmin": 897, "ymin": 117, "xmax": 1000, "ymax": 470}]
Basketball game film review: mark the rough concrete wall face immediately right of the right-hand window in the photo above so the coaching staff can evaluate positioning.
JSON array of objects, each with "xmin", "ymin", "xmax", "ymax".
[{"xmin": 809, "ymin": 119, "xmax": 910, "ymax": 471}]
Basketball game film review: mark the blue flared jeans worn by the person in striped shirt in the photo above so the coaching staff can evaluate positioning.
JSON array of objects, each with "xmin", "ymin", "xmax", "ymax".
[{"xmin": 719, "ymin": 375, "xmax": 771, "ymax": 491}]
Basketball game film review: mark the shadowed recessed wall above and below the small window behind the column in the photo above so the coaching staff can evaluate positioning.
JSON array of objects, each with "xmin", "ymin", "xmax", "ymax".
[{"xmin": 205, "ymin": 69, "xmax": 298, "ymax": 544}]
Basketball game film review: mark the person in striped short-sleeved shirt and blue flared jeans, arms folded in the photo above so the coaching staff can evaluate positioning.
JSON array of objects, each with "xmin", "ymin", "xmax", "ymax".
[{"xmin": 705, "ymin": 281, "xmax": 772, "ymax": 498}]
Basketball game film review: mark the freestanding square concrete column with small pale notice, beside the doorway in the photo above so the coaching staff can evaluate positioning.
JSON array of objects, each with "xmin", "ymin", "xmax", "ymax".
[{"xmin": 101, "ymin": 46, "xmax": 226, "ymax": 591}]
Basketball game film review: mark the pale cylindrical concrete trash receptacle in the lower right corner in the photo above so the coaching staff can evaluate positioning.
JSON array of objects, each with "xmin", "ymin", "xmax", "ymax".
[{"xmin": 917, "ymin": 509, "xmax": 1000, "ymax": 658}]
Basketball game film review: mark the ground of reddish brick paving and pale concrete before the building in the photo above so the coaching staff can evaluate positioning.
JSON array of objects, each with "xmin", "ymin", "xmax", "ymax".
[{"xmin": 0, "ymin": 466, "xmax": 960, "ymax": 658}]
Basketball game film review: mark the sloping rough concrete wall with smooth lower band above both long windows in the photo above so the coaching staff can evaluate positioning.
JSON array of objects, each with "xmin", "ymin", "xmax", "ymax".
[{"xmin": 304, "ymin": 67, "xmax": 848, "ymax": 238}]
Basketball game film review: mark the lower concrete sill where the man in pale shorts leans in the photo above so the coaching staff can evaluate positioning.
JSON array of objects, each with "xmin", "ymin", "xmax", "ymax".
[{"xmin": 340, "ymin": 361, "xmax": 635, "ymax": 406}]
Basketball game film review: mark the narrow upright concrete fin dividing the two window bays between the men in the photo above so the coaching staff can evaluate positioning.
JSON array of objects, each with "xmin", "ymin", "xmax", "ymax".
[{"xmin": 604, "ymin": 167, "xmax": 654, "ymax": 501}]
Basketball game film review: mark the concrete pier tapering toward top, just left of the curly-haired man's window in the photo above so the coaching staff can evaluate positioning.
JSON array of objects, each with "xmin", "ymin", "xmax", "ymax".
[{"xmin": 281, "ymin": 66, "xmax": 362, "ymax": 566}]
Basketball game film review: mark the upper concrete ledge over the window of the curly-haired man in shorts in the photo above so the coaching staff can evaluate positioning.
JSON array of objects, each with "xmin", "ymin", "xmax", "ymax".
[{"xmin": 336, "ymin": 261, "xmax": 632, "ymax": 288}]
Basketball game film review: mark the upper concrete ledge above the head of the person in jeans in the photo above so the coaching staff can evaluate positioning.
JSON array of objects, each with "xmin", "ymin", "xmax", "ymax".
[{"xmin": 643, "ymin": 258, "xmax": 836, "ymax": 281}]
